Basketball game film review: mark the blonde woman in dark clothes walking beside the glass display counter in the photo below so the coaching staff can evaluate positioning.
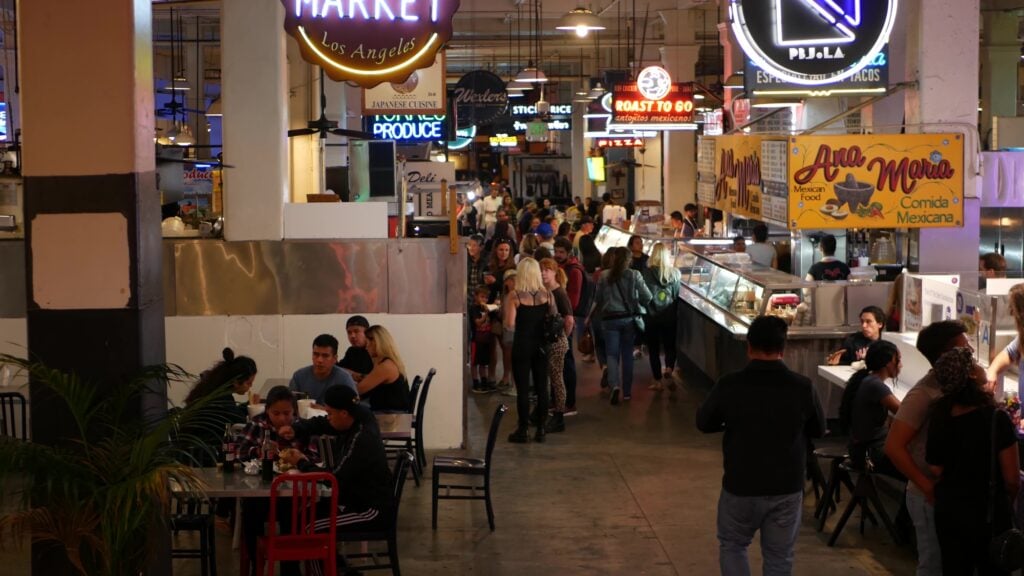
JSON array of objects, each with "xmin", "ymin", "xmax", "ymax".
[{"xmin": 643, "ymin": 242, "xmax": 680, "ymax": 392}]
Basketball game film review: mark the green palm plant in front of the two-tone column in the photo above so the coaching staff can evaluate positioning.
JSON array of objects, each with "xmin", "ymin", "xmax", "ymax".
[{"xmin": 0, "ymin": 355, "xmax": 226, "ymax": 576}]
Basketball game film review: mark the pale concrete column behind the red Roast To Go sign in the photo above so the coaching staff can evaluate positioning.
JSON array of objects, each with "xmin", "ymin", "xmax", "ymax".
[{"xmin": 659, "ymin": 9, "xmax": 700, "ymax": 213}]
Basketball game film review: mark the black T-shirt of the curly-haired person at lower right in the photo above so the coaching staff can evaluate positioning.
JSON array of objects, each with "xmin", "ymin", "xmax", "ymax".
[{"xmin": 925, "ymin": 399, "xmax": 1017, "ymax": 502}]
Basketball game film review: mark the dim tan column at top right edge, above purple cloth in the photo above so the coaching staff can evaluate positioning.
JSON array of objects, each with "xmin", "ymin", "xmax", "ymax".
[{"xmin": 981, "ymin": 12, "xmax": 1021, "ymax": 148}]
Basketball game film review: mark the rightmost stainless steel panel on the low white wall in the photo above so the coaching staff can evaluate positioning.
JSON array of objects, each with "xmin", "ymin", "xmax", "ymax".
[{"xmin": 387, "ymin": 239, "xmax": 447, "ymax": 314}]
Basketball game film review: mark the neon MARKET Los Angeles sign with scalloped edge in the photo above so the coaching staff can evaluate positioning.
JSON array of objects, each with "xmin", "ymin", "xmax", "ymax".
[{"xmin": 281, "ymin": 0, "xmax": 460, "ymax": 88}]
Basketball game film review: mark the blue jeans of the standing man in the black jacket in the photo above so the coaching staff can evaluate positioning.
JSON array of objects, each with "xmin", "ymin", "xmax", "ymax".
[{"xmin": 718, "ymin": 488, "xmax": 804, "ymax": 576}]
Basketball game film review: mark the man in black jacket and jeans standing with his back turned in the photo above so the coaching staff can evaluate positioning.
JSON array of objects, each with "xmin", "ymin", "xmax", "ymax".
[{"xmin": 697, "ymin": 316, "xmax": 825, "ymax": 576}]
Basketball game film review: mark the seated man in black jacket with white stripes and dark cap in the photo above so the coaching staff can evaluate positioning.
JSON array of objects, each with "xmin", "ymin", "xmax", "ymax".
[{"xmin": 281, "ymin": 385, "xmax": 392, "ymax": 576}]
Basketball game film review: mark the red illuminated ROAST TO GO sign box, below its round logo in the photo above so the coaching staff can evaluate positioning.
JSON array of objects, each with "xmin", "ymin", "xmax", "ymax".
[{"xmin": 608, "ymin": 82, "xmax": 696, "ymax": 130}]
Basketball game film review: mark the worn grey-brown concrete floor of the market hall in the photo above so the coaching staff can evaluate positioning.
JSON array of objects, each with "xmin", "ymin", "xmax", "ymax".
[{"xmin": 0, "ymin": 352, "xmax": 914, "ymax": 576}]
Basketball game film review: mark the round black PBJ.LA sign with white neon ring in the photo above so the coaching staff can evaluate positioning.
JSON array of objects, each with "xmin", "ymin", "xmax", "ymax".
[{"xmin": 729, "ymin": 0, "xmax": 898, "ymax": 86}]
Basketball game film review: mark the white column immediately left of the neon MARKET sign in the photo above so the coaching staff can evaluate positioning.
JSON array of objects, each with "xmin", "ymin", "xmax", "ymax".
[{"xmin": 220, "ymin": 0, "xmax": 290, "ymax": 241}]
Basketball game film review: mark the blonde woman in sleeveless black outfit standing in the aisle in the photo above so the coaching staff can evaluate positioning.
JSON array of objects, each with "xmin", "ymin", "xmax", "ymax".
[{"xmin": 503, "ymin": 257, "xmax": 555, "ymax": 444}]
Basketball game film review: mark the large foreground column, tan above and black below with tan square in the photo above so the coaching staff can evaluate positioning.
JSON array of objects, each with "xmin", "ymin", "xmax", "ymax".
[{"xmin": 19, "ymin": 0, "xmax": 170, "ymax": 575}]
